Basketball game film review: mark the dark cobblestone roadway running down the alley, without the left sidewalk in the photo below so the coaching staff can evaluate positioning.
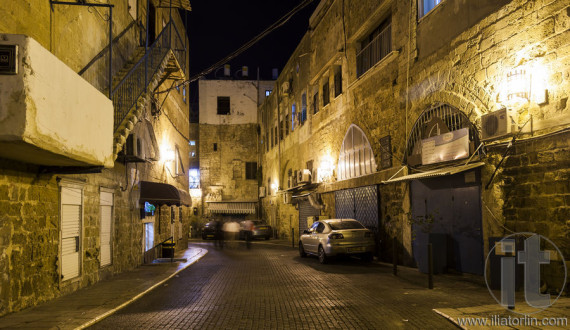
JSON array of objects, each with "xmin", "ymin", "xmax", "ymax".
[{"xmin": 87, "ymin": 242, "xmax": 490, "ymax": 329}]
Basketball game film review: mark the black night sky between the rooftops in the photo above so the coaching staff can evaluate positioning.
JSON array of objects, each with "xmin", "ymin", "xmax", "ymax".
[{"xmin": 188, "ymin": 0, "xmax": 319, "ymax": 79}]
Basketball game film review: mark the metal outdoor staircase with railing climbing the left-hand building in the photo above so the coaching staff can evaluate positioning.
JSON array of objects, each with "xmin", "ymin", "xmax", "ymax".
[{"xmin": 110, "ymin": 21, "xmax": 186, "ymax": 159}]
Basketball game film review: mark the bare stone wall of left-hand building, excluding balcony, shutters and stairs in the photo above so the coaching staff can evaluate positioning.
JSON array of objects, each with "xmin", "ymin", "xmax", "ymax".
[{"xmin": 0, "ymin": 0, "xmax": 191, "ymax": 315}]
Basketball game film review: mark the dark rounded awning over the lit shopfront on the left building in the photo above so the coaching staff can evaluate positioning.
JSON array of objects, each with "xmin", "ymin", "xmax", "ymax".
[{"xmin": 139, "ymin": 181, "xmax": 192, "ymax": 206}]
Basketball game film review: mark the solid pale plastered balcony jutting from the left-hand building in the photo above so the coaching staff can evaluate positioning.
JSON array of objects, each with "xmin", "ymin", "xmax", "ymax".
[{"xmin": 0, "ymin": 34, "xmax": 114, "ymax": 168}]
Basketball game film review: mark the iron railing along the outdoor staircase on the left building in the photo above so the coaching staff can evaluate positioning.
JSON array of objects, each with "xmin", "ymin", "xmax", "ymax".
[{"xmin": 111, "ymin": 20, "xmax": 186, "ymax": 131}]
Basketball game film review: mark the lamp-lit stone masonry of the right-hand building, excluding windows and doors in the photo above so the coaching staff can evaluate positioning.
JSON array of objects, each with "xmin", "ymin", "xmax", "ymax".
[{"xmin": 259, "ymin": 0, "xmax": 570, "ymax": 270}]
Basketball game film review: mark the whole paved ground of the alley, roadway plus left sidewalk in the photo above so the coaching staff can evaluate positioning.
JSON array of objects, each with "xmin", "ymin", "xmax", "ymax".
[{"xmin": 0, "ymin": 240, "xmax": 570, "ymax": 329}]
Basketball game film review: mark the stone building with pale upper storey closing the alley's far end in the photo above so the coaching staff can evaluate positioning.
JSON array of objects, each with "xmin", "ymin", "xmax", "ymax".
[{"xmin": 197, "ymin": 79, "xmax": 274, "ymax": 221}]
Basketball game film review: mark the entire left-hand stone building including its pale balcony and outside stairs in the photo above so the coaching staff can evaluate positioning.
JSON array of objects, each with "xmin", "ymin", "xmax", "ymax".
[{"xmin": 0, "ymin": 0, "xmax": 191, "ymax": 315}]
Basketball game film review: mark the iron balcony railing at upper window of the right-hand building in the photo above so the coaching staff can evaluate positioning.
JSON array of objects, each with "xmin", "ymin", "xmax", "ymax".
[{"xmin": 356, "ymin": 25, "xmax": 392, "ymax": 77}]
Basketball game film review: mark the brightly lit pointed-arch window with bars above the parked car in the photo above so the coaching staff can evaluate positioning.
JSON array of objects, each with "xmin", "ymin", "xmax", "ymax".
[{"xmin": 338, "ymin": 124, "xmax": 376, "ymax": 180}]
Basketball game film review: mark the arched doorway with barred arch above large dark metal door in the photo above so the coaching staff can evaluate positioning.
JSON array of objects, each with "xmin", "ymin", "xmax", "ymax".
[{"xmin": 405, "ymin": 104, "xmax": 483, "ymax": 275}]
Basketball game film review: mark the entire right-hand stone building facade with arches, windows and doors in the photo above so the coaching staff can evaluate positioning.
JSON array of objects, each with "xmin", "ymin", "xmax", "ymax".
[{"xmin": 258, "ymin": 0, "xmax": 570, "ymax": 289}]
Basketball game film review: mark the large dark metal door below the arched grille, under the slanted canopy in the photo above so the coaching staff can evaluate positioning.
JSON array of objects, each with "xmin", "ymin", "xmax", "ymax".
[{"xmin": 411, "ymin": 171, "xmax": 484, "ymax": 275}]
